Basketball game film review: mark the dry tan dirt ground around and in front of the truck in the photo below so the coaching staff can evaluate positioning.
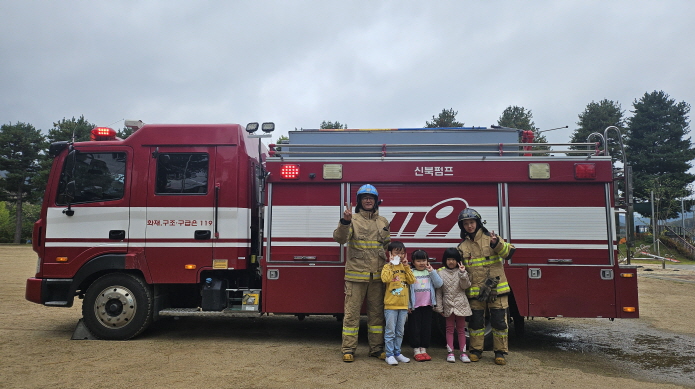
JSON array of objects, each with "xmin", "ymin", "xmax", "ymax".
[{"xmin": 0, "ymin": 245, "xmax": 695, "ymax": 388}]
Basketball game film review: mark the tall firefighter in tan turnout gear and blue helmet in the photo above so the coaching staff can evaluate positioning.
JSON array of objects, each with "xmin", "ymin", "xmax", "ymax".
[{"xmin": 333, "ymin": 184, "xmax": 391, "ymax": 362}]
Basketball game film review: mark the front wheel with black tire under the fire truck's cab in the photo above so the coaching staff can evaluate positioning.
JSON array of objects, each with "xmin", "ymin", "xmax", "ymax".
[{"xmin": 82, "ymin": 273, "xmax": 153, "ymax": 340}]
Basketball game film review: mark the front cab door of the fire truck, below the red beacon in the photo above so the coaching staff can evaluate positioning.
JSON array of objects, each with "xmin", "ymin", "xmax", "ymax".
[{"xmin": 43, "ymin": 146, "xmax": 132, "ymax": 278}]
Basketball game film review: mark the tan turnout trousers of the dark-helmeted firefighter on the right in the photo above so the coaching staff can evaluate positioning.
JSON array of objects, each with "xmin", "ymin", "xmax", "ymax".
[{"xmin": 468, "ymin": 295, "xmax": 509, "ymax": 354}]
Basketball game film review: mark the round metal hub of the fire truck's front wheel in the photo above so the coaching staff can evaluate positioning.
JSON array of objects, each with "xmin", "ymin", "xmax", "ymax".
[{"xmin": 94, "ymin": 286, "xmax": 137, "ymax": 328}]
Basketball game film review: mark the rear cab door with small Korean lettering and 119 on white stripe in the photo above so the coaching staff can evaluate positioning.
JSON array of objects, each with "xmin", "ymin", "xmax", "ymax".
[{"xmin": 145, "ymin": 146, "xmax": 215, "ymax": 283}]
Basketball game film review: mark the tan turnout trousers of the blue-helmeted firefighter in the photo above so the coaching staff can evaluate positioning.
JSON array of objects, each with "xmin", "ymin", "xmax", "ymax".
[{"xmin": 341, "ymin": 277, "xmax": 385, "ymax": 355}]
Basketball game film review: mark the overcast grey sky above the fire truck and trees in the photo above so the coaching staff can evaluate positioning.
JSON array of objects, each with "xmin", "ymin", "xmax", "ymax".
[{"xmin": 0, "ymin": 0, "xmax": 695, "ymax": 142}]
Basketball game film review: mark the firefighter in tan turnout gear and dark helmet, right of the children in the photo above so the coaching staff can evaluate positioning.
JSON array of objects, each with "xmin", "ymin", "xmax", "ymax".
[{"xmin": 458, "ymin": 208, "xmax": 514, "ymax": 365}]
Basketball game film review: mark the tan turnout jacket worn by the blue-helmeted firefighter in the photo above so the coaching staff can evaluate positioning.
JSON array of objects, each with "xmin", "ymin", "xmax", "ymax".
[{"xmin": 333, "ymin": 210, "xmax": 391, "ymax": 282}]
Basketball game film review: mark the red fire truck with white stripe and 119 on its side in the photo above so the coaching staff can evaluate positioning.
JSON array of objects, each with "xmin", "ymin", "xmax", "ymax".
[{"xmin": 26, "ymin": 123, "xmax": 639, "ymax": 339}]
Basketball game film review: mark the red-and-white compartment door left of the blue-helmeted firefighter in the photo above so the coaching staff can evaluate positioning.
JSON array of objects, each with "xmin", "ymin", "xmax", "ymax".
[{"xmin": 263, "ymin": 183, "xmax": 345, "ymax": 314}]
